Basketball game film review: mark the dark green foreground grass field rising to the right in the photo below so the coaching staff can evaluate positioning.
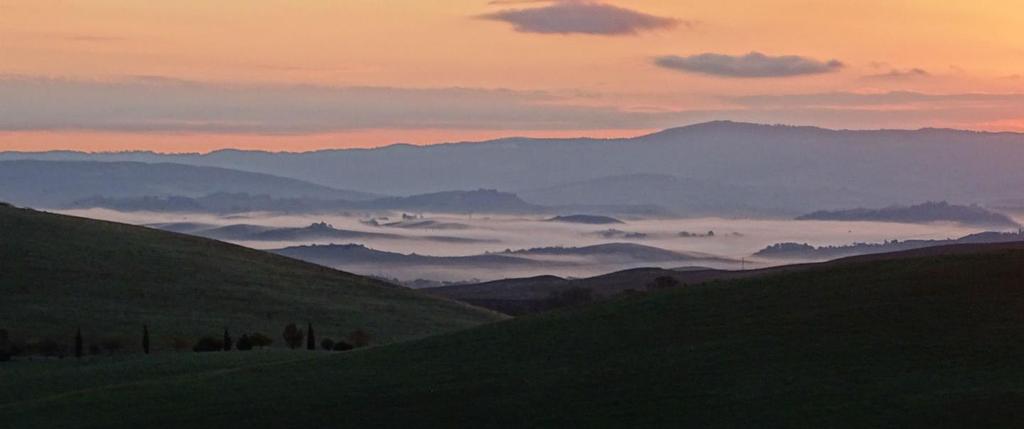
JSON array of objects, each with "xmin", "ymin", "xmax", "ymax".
[{"xmin": 0, "ymin": 241, "xmax": 1024, "ymax": 428}]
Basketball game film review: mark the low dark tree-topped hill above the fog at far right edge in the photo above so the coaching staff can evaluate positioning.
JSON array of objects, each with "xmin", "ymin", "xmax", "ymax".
[{"xmin": 797, "ymin": 201, "xmax": 1020, "ymax": 227}]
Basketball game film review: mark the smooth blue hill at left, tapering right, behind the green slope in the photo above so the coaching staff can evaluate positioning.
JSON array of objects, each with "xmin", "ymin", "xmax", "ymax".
[{"xmin": 0, "ymin": 161, "xmax": 373, "ymax": 208}]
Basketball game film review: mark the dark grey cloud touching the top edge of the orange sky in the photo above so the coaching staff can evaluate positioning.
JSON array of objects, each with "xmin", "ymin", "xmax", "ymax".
[{"xmin": 479, "ymin": 1, "xmax": 686, "ymax": 36}]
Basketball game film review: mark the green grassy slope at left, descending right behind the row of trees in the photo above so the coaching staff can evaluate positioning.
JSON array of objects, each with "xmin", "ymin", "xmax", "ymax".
[{"xmin": 0, "ymin": 206, "xmax": 501, "ymax": 350}]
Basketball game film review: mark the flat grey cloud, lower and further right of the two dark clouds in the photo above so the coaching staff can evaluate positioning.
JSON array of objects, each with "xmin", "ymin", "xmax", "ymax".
[{"xmin": 654, "ymin": 52, "xmax": 843, "ymax": 78}]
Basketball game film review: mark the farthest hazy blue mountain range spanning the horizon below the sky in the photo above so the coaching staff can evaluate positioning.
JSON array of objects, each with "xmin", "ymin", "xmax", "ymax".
[{"xmin": 8, "ymin": 122, "xmax": 1024, "ymax": 215}]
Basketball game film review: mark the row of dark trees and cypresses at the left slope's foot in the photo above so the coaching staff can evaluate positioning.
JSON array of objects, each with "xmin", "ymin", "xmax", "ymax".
[{"xmin": 0, "ymin": 324, "xmax": 371, "ymax": 361}]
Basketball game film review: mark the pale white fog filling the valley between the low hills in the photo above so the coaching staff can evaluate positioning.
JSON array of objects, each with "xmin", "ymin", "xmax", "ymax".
[{"xmin": 60, "ymin": 209, "xmax": 983, "ymax": 283}]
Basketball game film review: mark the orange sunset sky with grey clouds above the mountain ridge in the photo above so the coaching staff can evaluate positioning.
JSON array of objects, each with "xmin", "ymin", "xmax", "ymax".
[{"xmin": 0, "ymin": 0, "xmax": 1024, "ymax": 152}]
